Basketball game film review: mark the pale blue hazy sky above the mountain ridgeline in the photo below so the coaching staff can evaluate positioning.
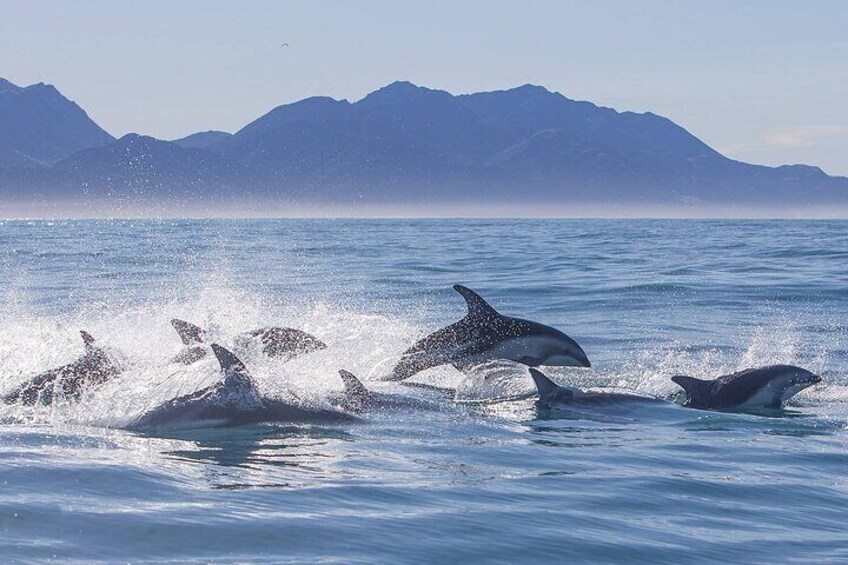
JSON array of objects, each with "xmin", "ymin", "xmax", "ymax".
[{"xmin": 0, "ymin": 0, "xmax": 848, "ymax": 175}]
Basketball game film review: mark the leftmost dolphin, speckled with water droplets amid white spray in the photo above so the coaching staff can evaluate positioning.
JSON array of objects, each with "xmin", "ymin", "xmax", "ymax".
[{"xmin": 3, "ymin": 331, "xmax": 121, "ymax": 406}]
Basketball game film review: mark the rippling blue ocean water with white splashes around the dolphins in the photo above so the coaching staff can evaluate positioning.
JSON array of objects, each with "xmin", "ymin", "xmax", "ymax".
[{"xmin": 0, "ymin": 219, "xmax": 848, "ymax": 564}]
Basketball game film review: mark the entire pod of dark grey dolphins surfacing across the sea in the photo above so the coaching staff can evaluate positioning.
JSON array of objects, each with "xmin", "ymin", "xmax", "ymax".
[{"xmin": 0, "ymin": 285, "xmax": 821, "ymax": 430}]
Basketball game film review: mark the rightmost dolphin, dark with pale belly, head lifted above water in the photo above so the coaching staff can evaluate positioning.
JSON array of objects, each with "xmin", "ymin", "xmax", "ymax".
[{"xmin": 671, "ymin": 365, "xmax": 821, "ymax": 410}]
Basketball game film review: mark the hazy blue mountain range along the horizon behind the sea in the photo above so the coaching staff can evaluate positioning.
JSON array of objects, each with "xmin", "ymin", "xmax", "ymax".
[{"xmin": 0, "ymin": 79, "xmax": 848, "ymax": 213}]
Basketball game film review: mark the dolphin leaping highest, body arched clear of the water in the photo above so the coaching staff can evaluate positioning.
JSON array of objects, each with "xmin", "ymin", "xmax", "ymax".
[{"xmin": 384, "ymin": 285, "xmax": 591, "ymax": 381}]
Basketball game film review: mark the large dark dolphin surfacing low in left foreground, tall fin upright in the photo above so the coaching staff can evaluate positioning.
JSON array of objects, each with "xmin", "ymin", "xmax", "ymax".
[{"xmin": 134, "ymin": 343, "xmax": 354, "ymax": 431}]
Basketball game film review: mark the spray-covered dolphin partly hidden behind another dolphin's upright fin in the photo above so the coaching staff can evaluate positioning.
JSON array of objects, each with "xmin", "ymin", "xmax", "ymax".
[{"xmin": 171, "ymin": 318, "xmax": 327, "ymax": 365}]
